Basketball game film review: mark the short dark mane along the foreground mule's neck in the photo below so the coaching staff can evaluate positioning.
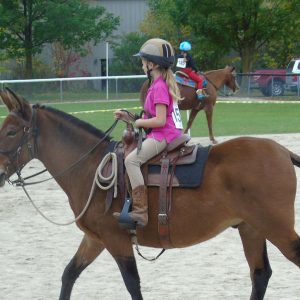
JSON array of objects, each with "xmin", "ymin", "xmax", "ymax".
[{"xmin": 33, "ymin": 104, "xmax": 111, "ymax": 141}]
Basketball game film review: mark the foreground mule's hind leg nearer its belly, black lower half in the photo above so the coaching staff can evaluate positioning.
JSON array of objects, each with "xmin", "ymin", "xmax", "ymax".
[{"xmin": 238, "ymin": 223, "xmax": 272, "ymax": 300}]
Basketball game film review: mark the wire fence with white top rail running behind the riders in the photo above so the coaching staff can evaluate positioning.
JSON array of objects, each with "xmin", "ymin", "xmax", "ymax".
[{"xmin": 0, "ymin": 73, "xmax": 300, "ymax": 102}]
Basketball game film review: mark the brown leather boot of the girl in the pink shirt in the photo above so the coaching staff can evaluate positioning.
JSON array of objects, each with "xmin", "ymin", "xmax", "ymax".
[{"xmin": 113, "ymin": 185, "xmax": 148, "ymax": 227}]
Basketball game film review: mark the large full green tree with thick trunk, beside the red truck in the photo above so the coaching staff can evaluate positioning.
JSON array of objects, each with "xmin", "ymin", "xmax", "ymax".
[{"xmin": 189, "ymin": 0, "xmax": 300, "ymax": 73}]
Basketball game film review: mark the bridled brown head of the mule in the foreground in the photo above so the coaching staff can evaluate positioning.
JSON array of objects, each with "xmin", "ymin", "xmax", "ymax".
[{"xmin": 0, "ymin": 89, "xmax": 33, "ymax": 186}]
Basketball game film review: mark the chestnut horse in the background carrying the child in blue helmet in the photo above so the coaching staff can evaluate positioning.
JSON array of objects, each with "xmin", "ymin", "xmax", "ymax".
[{"xmin": 140, "ymin": 66, "xmax": 239, "ymax": 144}]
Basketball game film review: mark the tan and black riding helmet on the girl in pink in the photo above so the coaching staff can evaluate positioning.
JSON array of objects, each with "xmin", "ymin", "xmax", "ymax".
[{"xmin": 134, "ymin": 38, "xmax": 175, "ymax": 69}]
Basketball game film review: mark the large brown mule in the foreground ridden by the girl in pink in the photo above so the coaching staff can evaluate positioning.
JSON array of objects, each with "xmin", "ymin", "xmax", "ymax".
[{"xmin": 0, "ymin": 90, "xmax": 300, "ymax": 300}]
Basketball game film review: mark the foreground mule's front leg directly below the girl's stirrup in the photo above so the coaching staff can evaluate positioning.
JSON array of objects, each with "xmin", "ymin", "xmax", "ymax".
[{"xmin": 106, "ymin": 238, "xmax": 143, "ymax": 300}]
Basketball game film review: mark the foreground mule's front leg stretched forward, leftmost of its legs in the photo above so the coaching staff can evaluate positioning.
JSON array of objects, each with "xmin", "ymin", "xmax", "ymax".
[{"xmin": 59, "ymin": 235, "xmax": 104, "ymax": 300}]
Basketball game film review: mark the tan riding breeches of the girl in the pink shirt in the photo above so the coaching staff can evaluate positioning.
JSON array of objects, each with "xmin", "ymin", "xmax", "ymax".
[{"xmin": 125, "ymin": 138, "xmax": 167, "ymax": 189}]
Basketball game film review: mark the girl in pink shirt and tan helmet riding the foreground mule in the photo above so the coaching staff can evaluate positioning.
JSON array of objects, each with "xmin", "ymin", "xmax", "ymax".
[{"xmin": 113, "ymin": 38, "xmax": 183, "ymax": 227}]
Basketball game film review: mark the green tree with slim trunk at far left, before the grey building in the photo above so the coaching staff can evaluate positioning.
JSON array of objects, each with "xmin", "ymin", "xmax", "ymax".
[{"xmin": 0, "ymin": 0, "xmax": 119, "ymax": 78}]
